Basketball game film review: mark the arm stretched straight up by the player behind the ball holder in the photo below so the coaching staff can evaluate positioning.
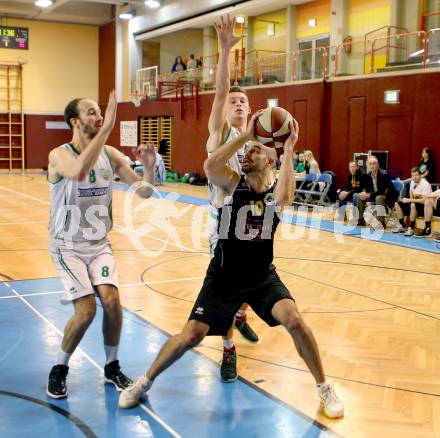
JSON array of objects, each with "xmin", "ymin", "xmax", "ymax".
[{"xmin": 207, "ymin": 15, "xmax": 243, "ymax": 152}]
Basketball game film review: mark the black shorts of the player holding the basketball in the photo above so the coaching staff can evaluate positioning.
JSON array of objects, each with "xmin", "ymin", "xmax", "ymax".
[{"xmin": 188, "ymin": 268, "xmax": 293, "ymax": 336}]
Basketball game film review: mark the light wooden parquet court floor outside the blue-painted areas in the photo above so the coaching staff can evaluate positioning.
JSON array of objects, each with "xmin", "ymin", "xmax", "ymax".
[{"xmin": 0, "ymin": 174, "xmax": 440, "ymax": 438}]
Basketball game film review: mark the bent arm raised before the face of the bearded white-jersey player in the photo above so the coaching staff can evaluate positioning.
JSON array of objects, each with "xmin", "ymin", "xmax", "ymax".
[{"xmin": 48, "ymin": 91, "xmax": 117, "ymax": 181}]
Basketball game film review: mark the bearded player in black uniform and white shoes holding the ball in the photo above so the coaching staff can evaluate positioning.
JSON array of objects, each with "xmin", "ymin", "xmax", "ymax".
[{"xmin": 119, "ymin": 113, "xmax": 344, "ymax": 418}]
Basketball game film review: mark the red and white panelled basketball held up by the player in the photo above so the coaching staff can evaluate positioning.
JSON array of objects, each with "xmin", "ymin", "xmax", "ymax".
[{"xmin": 255, "ymin": 106, "xmax": 293, "ymax": 156}]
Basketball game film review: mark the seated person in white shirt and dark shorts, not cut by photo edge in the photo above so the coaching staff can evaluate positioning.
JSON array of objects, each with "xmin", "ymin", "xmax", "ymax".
[{"xmin": 392, "ymin": 167, "xmax": 432, "ymax": 237}]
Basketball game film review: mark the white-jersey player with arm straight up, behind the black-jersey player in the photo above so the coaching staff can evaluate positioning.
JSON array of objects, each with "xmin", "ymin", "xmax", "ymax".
[{"xmin": 206, "ymin": 15, "xmax": 258, "ymax": 382}]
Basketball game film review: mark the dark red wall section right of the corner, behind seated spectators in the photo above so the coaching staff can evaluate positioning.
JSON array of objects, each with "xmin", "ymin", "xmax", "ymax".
[{"xmin": 321, "ymin": 73, "xmax": 440, "ymax": 179}]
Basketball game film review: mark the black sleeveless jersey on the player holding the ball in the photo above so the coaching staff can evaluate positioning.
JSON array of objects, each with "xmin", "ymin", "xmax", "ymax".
[{"xmin": 208, "ymin": 175, "xmax": 280, "ymax": 285}]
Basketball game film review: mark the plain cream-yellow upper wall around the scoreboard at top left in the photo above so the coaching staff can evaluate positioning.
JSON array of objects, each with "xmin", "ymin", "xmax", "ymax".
[{"xmin": 0, "ymin": 18, "xmax": 99, "ymax": 114}]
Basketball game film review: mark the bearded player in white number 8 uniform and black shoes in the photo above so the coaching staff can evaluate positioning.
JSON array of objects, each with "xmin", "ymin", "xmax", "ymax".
[{"xmin": 47, "ymin": 91, "xmax": 155, "ymax": 398}]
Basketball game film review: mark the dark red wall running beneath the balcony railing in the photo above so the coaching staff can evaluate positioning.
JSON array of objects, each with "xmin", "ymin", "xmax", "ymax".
[{"xmin": 100, "ymin": 69, "xmax": 440, "ymax": 184}]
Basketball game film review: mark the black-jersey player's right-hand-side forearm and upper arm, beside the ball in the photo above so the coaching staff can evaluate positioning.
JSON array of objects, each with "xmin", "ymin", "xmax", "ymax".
[{"xmin": 275, "ymin": 119, "xmax": 299, "ymax": 207}]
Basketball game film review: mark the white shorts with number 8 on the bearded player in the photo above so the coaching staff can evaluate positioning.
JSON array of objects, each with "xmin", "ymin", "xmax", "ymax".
[{"xmin": 50, "ymin": 239, "xmax": 118, "ymax": 304}]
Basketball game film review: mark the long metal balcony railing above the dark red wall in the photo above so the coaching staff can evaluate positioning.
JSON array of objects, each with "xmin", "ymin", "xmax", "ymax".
[{"xmin": 136, "ymin": 30, "xmax": 440, "ymax": 95}]
